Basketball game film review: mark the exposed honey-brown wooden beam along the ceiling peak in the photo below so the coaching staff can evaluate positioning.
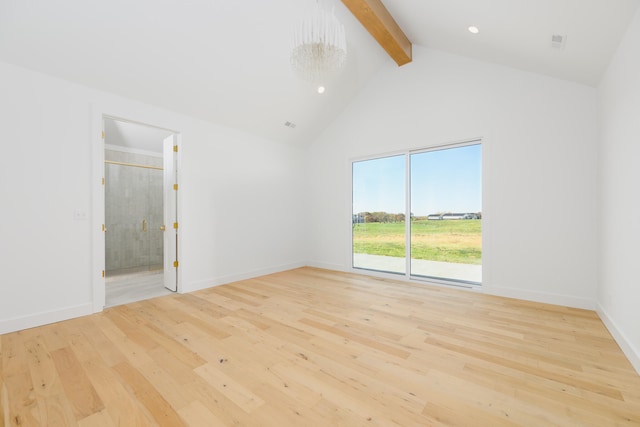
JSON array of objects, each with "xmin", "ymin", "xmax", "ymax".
[{"xmin": 342, "ymin": 0, "xmax": 411, "ymax": 66}]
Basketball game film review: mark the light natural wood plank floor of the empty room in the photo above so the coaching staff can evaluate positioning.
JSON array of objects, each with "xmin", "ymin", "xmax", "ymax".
[{"xmin": 0, "ymin": 268, "xmax": 640, "ymax": 427}]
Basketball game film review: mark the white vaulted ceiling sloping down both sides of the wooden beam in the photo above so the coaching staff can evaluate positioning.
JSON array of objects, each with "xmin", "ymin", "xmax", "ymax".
[{"xmin": 0, "ymin": 0, "xmax": 640, "ymax": 144}]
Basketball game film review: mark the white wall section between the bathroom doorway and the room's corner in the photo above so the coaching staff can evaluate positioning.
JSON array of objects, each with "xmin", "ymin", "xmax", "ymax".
[{"xmin": 181, "ymin": 119, "xmax": 307, "ymax": 291}]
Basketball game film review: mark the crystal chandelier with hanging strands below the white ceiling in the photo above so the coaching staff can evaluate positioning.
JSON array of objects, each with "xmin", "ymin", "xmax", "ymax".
[{"xmin": 291, "ymin": 3, "xmax": 347, "ymax": 84}]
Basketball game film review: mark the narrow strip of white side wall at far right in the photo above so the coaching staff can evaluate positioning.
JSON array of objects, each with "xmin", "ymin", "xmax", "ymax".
[{"xmin": 598, "ymin": 7, "xmax": 640, "ymax": 372}]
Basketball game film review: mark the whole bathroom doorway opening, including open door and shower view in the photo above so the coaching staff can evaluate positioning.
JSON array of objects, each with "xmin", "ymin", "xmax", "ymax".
[{"xmin": 103, "ymin": 116, "xmax": 177, "ymax": 307}]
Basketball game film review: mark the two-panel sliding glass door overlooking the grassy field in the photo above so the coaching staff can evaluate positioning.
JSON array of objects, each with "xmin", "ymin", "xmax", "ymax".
[{"xmin": 352, "ymin": 141, "xmax": 482, "ymax": 284}]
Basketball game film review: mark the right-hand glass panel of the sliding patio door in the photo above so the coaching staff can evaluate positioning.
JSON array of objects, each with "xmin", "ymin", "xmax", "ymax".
[{"xmin": 410, "ymin": 144, "xmax": 482, "ymax": 284}]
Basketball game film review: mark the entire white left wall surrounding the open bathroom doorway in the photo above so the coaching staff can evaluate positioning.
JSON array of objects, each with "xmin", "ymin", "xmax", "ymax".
[{"xmin": 0, "ymin": 63, "xmax": 306, "ymax": 333}]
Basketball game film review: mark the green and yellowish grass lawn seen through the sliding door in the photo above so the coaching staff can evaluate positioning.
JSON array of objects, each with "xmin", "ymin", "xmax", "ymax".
[{"xmin": 353, "ymin": 219, "xmax": 482, "ymax": 264}]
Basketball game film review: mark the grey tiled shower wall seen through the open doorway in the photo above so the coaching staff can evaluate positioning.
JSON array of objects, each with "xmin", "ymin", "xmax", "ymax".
[{"xmin": 105, "ymin": 149, "xmax": 163, "ymax": 273}]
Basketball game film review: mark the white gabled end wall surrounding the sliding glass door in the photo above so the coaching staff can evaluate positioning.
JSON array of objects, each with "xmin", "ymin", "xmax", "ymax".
[{"xmin": 308, "ymin": 46, "xmax": 598, "ymax": 308}]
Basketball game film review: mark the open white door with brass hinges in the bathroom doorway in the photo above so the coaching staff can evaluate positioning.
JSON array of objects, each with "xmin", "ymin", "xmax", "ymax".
[{"xmin": 163, "ymin": 135, "xmax": 178, "ymax": 292}]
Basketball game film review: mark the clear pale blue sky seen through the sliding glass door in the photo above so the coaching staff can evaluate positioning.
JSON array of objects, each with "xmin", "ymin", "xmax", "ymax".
[{"xmin": 353, "ymin": 144, "xmax": 482, "ymax": 216}]
